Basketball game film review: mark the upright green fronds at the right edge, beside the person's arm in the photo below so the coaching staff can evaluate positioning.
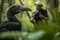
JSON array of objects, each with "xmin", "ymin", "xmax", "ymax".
[{"xmin": 49, "ymin": 8, "xmax": 60, "ymax": 29}]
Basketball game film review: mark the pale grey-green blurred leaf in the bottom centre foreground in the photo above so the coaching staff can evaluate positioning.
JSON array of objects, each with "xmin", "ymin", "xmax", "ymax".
[{"xmin": 22, "ymin": 30, "xmax": 45, "ymax": 40}]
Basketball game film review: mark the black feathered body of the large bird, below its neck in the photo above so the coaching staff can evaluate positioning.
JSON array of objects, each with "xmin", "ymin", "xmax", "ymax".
[{"xmin": 0, "ymin": 22, "xmax": 22, "ymax": 32}]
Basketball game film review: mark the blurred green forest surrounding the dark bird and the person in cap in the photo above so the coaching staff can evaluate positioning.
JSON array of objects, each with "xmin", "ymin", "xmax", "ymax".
[{"xmin": 0, "ymin": 0, "xmax": 60, "ymax": 40}]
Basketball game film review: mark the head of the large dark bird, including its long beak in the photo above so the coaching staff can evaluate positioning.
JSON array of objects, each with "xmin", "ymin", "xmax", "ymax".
[{"xmin": 8, "ymin": 5, "xmax": 31, "ymax": 13}]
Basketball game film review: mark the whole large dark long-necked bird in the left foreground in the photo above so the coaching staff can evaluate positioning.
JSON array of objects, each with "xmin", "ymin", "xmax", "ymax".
[{"xmin": 0, "ymin": 5, "xmax": 31, "ymax": 32}]
